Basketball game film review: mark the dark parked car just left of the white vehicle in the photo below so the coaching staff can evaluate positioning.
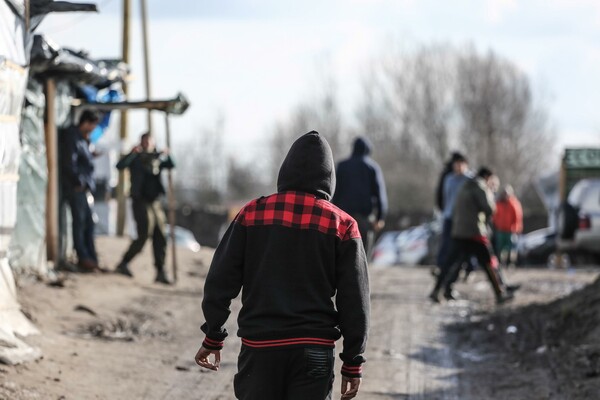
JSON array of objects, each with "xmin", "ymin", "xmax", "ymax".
[{"xmin": 517, "ymin": 228, "xmax": 556, "ymax": 265}]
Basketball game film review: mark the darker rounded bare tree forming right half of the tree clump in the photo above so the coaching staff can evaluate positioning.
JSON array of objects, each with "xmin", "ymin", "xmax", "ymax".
[{"xmin": 456, "ymin": 48, "xmax": 554, "ymax": 188}]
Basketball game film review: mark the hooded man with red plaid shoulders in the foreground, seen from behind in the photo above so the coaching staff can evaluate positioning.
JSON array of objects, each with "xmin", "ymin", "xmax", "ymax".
[{"xmin": 196, "ymin": 131, "xmax": 370, "ymax": 400}]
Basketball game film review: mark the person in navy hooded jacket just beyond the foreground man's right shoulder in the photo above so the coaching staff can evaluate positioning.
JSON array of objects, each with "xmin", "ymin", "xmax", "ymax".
[{"xmin": 332, "ymin": 137, "xmax": 387, "ymax": 255}]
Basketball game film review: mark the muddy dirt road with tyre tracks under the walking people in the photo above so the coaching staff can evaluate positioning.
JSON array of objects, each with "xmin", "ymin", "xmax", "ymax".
[{"xmin": 0, "ymin": 238, "xmax": 596, "ymax": 400}]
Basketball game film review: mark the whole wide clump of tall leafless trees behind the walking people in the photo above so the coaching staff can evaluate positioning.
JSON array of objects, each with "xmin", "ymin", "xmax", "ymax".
[{"xmin": 356, "ymin": 45, "xmax": 553, "ymax": 210}]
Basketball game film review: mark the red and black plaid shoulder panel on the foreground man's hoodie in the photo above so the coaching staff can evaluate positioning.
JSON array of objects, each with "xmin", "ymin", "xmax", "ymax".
[{"xmin": 235, "ymin": 191, "xmax": 360, "ymax": 240}]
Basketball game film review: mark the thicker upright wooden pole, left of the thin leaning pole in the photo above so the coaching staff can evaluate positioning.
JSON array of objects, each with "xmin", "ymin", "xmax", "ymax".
[{"xmin": 117, "ymin": 0, "xmax": 131, "ymax": 236}]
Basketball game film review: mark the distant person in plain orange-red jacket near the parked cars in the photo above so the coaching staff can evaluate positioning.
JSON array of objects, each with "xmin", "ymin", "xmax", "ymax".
[{"xmin": 493, "ymin": 185, "xmax": 523, "ymax": 265}]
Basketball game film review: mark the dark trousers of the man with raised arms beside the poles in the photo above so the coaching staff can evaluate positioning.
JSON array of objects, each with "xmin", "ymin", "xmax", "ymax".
[{"xmin": 122, "ymin": 199, "xmax": 167, "ymax": 270}]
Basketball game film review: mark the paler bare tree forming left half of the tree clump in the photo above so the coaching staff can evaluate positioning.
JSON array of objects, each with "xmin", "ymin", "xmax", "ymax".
[{"xmin": 357, "ymin": 46, "xmax": 456, "ymax": 210}]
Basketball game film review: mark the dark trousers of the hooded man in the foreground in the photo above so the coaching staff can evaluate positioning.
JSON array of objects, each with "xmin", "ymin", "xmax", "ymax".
[{"xmin": 233, "ymin": 346, "xmax": 334, "ymax": 400}]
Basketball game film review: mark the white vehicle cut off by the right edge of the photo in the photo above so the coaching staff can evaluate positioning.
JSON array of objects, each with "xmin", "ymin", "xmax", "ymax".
[{"xmin": 557, "ymin": 179, "xmax": 600, "ymax": 254}]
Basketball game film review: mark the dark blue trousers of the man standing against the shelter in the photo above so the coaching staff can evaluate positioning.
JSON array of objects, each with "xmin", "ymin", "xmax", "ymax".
[{"xmin": 68, "ymin": 190, "xmax": 98, "ymax": 263}]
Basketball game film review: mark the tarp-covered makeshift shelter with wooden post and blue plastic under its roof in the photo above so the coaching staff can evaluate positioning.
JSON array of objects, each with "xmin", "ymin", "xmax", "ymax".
[{"xmin": 11, "ymin": 35, "xmax": 128, "ymax": 275}]
